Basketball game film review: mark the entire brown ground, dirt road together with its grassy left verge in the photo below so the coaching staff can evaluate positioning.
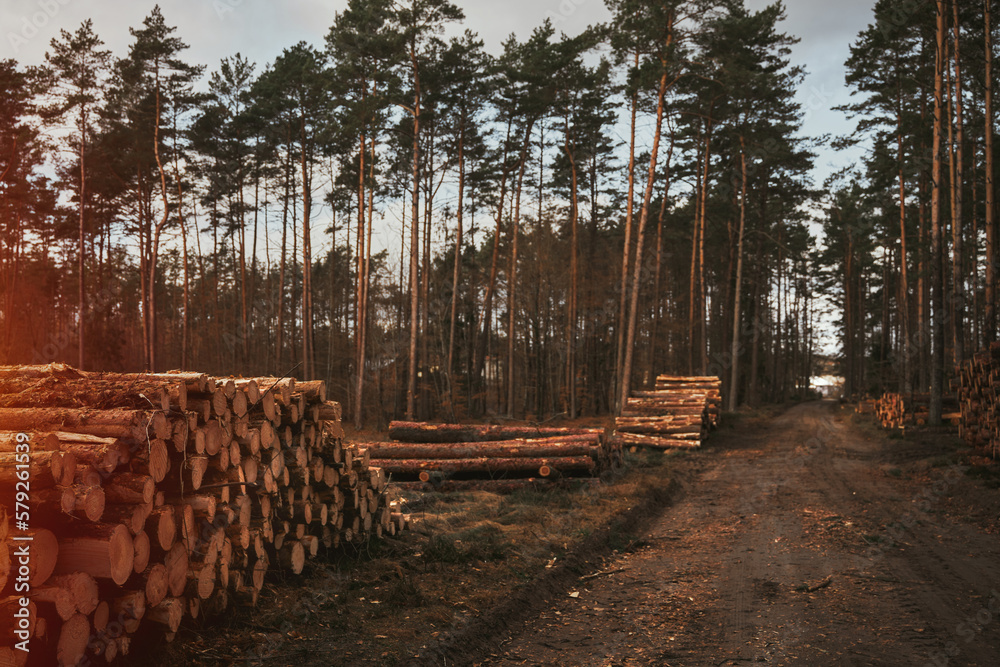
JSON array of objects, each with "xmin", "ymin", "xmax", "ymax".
[{"xmin": 152, "ymin": 401, "xmax": 1000, "ymax": 667}]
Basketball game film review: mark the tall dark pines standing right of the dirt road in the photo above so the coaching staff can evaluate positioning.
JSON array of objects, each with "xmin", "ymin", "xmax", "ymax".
[{"xmin": 821, "ymin": 0, "xmax": 998, "ymax": 421}]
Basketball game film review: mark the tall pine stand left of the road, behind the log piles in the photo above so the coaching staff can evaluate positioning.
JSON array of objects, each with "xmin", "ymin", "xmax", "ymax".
[{"xmin": 0, "ymin": 0, "xmax": 816, "ymax": 426}]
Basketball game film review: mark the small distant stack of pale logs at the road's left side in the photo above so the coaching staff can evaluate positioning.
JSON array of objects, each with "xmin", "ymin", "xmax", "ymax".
[{"xmin": 615, "ymin": 375, "xmax": 722, "ymax": 449}]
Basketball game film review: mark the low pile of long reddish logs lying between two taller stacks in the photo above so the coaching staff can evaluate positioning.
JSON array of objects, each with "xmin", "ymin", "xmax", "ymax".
[{"xmin": 361, "ymin": 421, "xmax": 621, "ymax": 492}]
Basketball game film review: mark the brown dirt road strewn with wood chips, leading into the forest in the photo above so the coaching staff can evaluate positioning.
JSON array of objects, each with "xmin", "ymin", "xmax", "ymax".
[{"xmin": 479, "ymin": 402, "xmax": 1000, "ymax": 667}]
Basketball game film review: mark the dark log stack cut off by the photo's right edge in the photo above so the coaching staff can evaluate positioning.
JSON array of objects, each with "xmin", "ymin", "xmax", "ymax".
[{"xmin": 957, "ymin": 343, "xmax": 1000, "ymax": 457}]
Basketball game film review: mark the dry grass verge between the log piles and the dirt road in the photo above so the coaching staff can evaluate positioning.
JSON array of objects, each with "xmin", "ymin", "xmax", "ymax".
[{"xmin": 145, "ymin": 440, "xmax": 680, "ymax": 667}]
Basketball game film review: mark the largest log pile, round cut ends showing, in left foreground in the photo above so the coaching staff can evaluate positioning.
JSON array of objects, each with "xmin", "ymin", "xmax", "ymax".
[{"xmin": 0, "ymin": 365, "xmax": 406, "ymax": 665}]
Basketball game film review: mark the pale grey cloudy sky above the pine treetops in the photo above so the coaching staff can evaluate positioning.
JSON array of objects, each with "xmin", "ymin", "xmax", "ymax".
[{"xmin": 0, "ymin": 0, "xmax": 874, "ymax": 185}]
